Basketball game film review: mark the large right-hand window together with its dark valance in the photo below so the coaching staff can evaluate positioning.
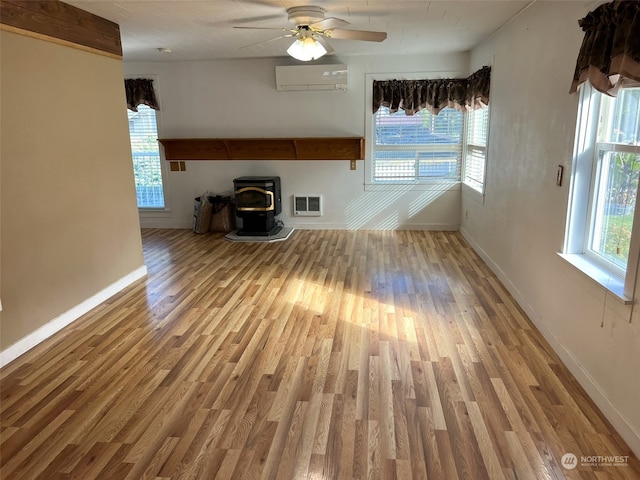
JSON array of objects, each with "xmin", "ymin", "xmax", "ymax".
[{"xmin": 563, "ymin": 1, "xmax": 640, "ymax": 303}]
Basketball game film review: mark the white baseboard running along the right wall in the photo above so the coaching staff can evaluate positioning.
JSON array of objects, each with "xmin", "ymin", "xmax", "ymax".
[{"xmin": 460, "ymin": 228, "xmax": 640, "ymax": 457}]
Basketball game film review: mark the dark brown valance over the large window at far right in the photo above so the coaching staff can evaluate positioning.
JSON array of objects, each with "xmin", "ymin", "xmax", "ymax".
[{"xmin": 570, "ymin": 0, "xmax": 640, "ymax": 95}]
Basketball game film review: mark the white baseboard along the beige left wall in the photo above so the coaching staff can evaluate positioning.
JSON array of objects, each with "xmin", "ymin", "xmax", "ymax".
[{"xmin": 0, "ymin": 265, "xmax": 147, "ymax": 367}]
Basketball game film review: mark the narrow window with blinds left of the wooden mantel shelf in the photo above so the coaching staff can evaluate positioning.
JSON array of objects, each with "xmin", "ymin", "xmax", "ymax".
[{"xmin": 127, "ymin": 105, "xmax": 165, "ymax": 208}]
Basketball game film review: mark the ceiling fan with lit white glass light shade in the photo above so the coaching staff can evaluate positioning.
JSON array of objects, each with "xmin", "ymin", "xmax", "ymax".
[{"xmin": 234, "ymin": 5, "xmax": 387, "ymax": 61}]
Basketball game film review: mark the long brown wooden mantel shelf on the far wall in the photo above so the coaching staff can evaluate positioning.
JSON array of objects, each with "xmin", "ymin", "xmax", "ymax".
[{"xmin": 160, "ymin": 137, "xmax": 364, "ymax": 160}]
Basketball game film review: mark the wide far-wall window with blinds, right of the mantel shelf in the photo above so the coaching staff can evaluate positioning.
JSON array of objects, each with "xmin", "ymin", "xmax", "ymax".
[{"xmin": 372, "ymin": 107, "xmax": 464, "ymax": 183}]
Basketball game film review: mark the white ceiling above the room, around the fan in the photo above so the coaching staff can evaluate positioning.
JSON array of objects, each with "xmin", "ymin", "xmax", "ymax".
[{"xmin": 66, "ymin": 0, "xmax": 533, "ymax": 61}]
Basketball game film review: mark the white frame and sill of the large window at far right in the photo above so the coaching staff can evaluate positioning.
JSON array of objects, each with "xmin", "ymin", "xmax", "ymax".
[{"xmin": 560, "ymin": 83, "xmax": 640, "ymax": 303}]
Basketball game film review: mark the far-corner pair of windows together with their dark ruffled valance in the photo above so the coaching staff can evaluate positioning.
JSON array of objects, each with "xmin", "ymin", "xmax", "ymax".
[{"xmin": 367, "ymin": 66, "xmax": 491, "ymax": 189}]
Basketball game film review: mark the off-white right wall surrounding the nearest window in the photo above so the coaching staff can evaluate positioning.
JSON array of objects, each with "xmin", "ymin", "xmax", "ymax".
[{"xmin": 461, "ymin": 1, "xmax": 640, "ymax": 454}]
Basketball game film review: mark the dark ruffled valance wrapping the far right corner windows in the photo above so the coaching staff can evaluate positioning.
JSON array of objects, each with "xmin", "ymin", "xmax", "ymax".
[{"xmin": 373, "ymin": 67, "xmax": 491, "ymax": 115}]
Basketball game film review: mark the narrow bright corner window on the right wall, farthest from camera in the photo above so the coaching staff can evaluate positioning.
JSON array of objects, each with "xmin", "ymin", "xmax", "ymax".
[{"xmin": 462, "ymin": 106, "xmax": 489, "ymax": 193}]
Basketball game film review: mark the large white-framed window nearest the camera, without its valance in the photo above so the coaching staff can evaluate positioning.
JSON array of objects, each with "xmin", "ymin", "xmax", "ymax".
[{"xmin": 565, "ymin": 84, "xmax": 640, "ymax": 298}]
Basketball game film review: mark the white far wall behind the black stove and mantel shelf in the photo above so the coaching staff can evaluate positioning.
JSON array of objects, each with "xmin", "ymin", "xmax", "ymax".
[{"xmin": 125, "ymin": 53, "xmax": 469, "ymax": 230}]
